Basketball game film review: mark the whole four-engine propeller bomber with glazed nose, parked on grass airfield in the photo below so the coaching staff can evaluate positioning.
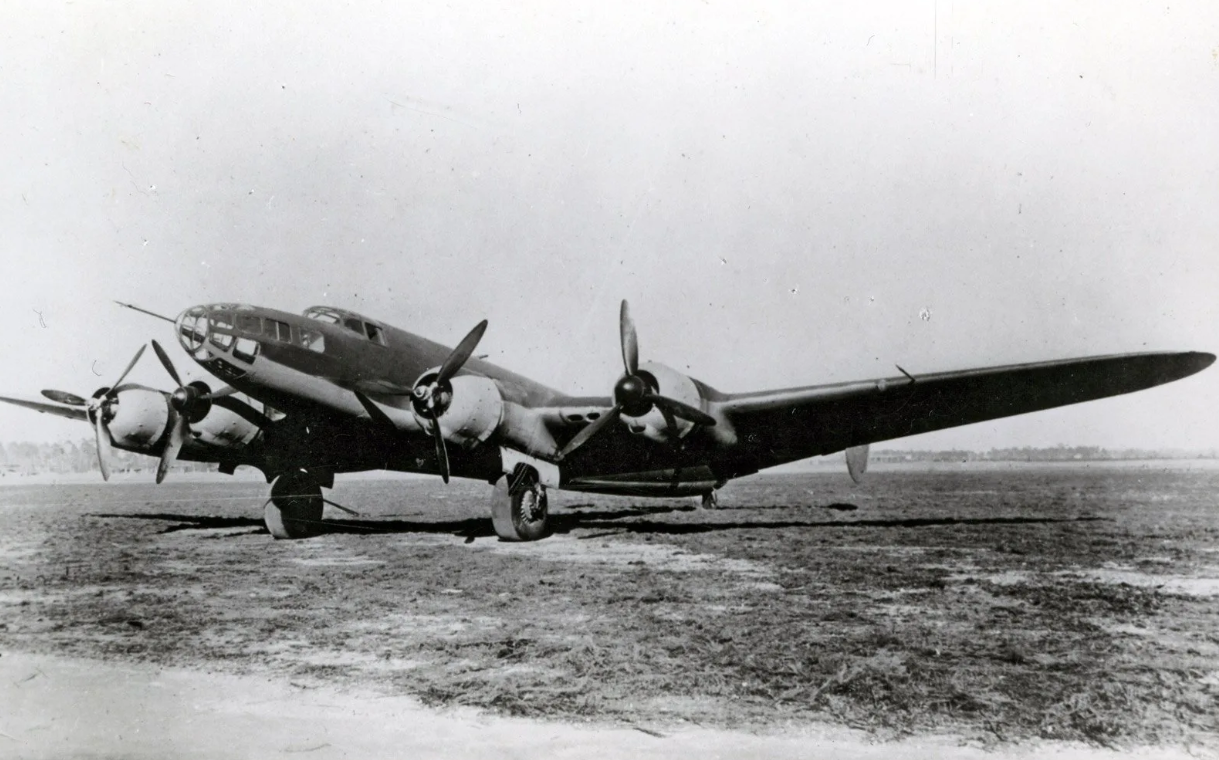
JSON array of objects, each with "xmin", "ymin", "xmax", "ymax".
[{"xmin": 0, "ymin": 301, "xmax": 1215, "ymax": 540}]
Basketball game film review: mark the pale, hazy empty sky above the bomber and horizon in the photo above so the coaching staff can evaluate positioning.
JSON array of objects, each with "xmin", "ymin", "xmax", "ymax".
[{"xmin": 0, "ymin": 0, "xmax": 1219, "ymax": 449}]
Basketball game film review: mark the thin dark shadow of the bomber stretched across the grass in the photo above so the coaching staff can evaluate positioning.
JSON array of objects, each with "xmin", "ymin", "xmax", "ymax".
[{"xmin": 87, "ymin": 505, "xmax": 1107, "ymax": 540}]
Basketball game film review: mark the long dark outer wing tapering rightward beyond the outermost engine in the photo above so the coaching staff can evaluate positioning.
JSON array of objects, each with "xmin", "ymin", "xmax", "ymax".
[{"xmin": 713, "ymin": 353, "xmax": 1215, "ymax": 467}]
